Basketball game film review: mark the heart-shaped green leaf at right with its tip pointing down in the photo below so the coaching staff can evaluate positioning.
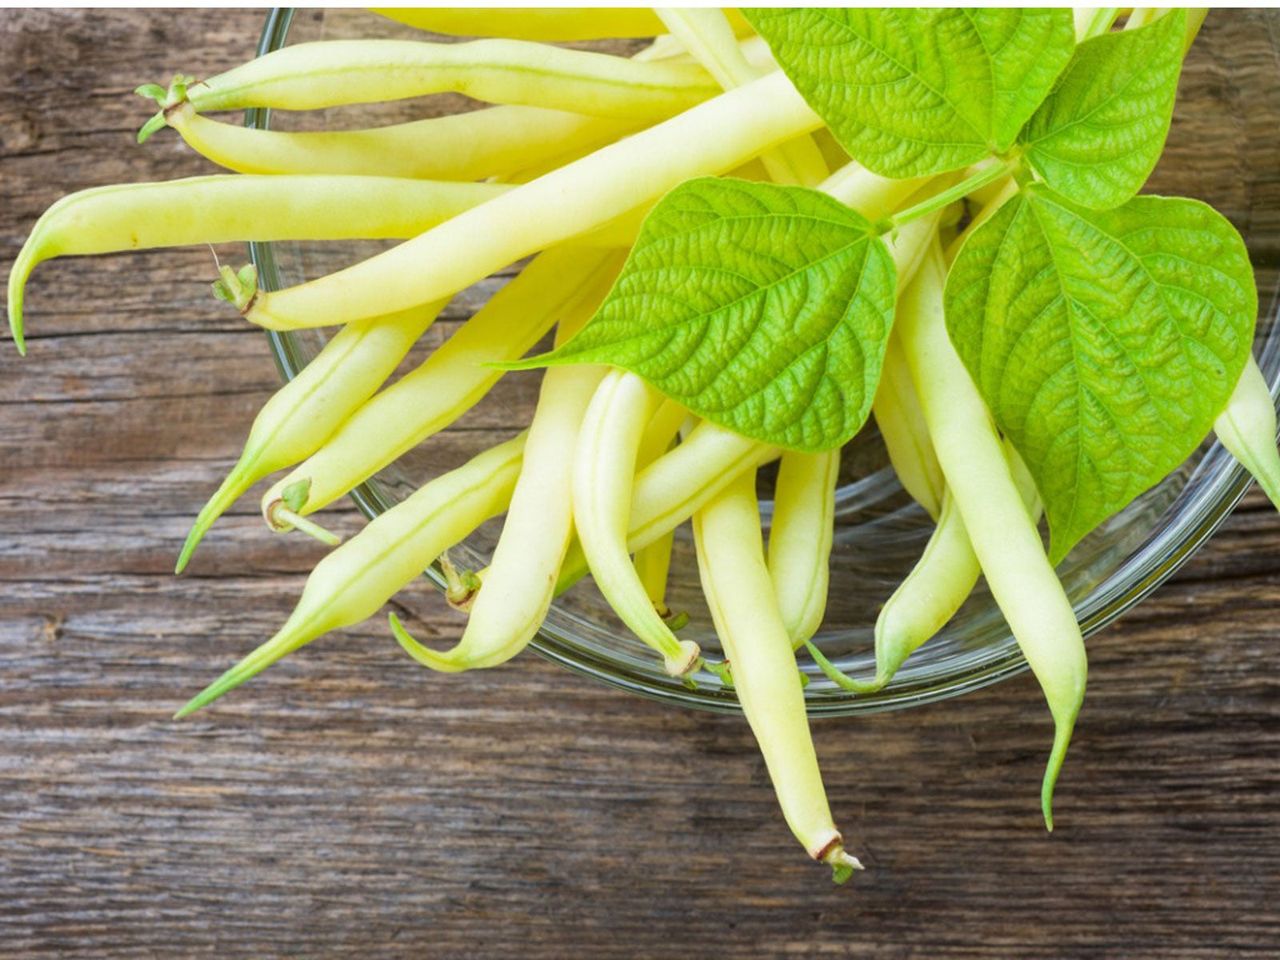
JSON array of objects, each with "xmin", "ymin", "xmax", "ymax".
[{"xmin": 946, "ymin": 184, "xmax": 1257, "ymax": 563}]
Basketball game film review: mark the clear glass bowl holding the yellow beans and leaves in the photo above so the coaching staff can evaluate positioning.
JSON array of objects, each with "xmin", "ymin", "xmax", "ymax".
[{"xmin": 247, "ymin": 10, "xmax": 1280, "ymax": 716}]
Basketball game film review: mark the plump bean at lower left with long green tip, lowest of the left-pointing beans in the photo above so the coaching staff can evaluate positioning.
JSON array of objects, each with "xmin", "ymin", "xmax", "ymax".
[{"xmin": 175, "ymin": 434, "xmax": 525, "ymax": 717}]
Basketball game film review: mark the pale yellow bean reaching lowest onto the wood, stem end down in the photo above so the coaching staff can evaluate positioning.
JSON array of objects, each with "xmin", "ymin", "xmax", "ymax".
[{"xmin": 694, "ymin": 470, "xmax": 861, "ymax": 879}]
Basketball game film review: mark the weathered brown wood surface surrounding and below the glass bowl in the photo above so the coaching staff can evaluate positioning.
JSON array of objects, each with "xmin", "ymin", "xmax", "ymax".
[{"xmin": 0, "ymin": 10, "xmax": 1280, "ymax": 960}]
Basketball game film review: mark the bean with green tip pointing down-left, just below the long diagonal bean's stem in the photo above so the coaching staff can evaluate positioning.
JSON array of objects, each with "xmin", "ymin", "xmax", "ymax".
[{"xmin": 174, "ymin": 302, "xmax": 444, "ymax": 573}]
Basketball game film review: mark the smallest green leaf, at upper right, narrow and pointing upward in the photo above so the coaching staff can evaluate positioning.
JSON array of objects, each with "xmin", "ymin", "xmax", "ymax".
[{"xmin": 1020, "ymin": 10, "xmax": 1187, "ymax": 210}]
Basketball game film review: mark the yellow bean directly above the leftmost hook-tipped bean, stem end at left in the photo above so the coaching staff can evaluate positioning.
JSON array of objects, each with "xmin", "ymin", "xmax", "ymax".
[{"xmin": 166, "ymin": 104, "xmax": 637, "ymax": 180}]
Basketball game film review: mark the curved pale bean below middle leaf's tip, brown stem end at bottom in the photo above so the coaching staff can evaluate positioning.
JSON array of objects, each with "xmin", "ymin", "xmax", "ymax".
[{"xmin": 573, "ymin": 370, "xmax": 700, "ymax": 677}]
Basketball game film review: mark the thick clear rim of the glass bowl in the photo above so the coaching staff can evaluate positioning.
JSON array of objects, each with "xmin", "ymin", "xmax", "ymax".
[{"xmin": 244, "ymin": 8, "xmax": 1280, "ymax": 717}]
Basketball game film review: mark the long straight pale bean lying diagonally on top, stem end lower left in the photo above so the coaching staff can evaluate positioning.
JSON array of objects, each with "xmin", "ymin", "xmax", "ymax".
[{"xmin": 238, "ymin": 73, "xmax": 822, "ymax": 329}]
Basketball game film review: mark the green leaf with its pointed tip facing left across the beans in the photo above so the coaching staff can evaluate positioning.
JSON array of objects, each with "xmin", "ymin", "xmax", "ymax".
[{"xmin": 506, "ymin": 177, "xmax": 896, "ymax": 452}]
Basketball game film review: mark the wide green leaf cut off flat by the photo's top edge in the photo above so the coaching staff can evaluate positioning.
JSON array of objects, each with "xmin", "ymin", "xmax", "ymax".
[{"xmin": 742, "ymin": 8, "xmax": 1075, "ymax": 178}]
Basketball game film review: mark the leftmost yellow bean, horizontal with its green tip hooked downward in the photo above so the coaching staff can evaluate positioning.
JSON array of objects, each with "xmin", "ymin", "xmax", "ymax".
[{"xmin": 9, "ymin": 174, "xmax": 511, "ymax": 352}]
